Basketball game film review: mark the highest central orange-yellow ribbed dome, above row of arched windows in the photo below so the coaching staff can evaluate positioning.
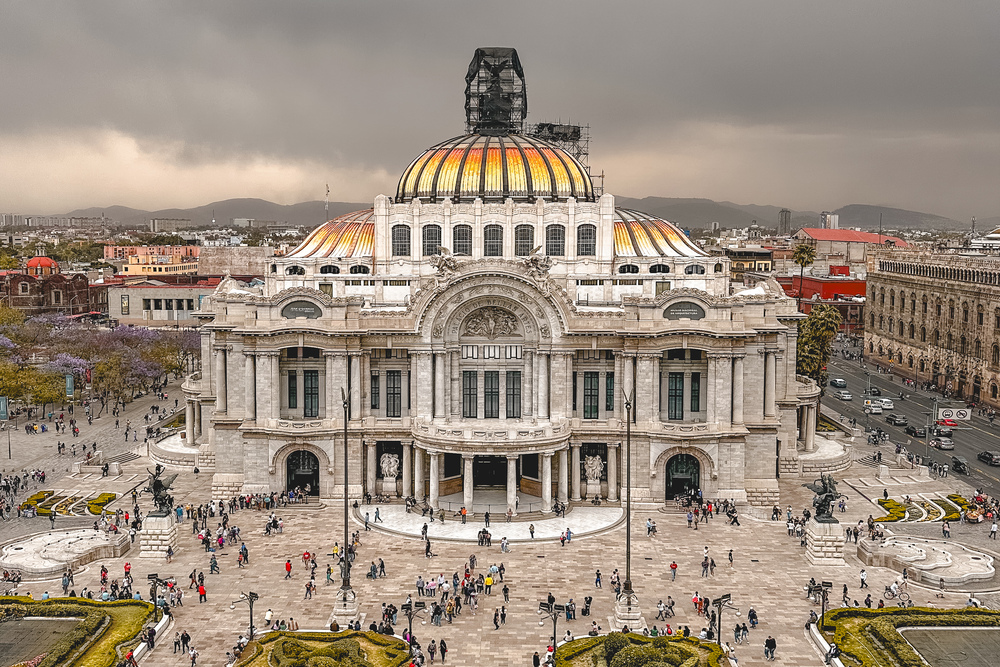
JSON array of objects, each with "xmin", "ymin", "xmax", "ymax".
[{"xmin": 396, "ymin": 134, "xmax": 594, "ymax": 202}]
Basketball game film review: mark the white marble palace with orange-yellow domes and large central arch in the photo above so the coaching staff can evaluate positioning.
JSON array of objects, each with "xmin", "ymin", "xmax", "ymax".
[{"xmin": 184, "ymin": 50, "xmax": 819, "ymax": 513}]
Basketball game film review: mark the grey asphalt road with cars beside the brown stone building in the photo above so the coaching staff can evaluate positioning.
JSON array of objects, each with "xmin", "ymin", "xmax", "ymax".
[{"xmin": 823, "ymin": 352, "xmax": 1000, "ymax": 496}]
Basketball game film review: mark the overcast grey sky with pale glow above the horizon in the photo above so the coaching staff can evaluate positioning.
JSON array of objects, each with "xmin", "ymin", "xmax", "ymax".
[{"xmin": 0, "ymin": 0, "xmax": 1000, "ymax": 219}]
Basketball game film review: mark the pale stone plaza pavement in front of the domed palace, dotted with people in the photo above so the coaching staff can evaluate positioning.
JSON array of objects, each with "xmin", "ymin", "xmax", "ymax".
[{"xmin": 3, "ymin": 388, "xmax": 989, "ymax": 666}]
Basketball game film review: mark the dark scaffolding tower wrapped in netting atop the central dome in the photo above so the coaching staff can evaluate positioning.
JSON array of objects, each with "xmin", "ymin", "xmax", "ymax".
[{"xmin": 465, "ymin": 47, "xmax": 528, "ymax": 137}]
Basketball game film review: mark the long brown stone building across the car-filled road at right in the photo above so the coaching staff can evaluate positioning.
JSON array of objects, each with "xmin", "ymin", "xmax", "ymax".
[{"xmin": 865, "ymin": 250, "xmax": 1000, "ymax": 407}]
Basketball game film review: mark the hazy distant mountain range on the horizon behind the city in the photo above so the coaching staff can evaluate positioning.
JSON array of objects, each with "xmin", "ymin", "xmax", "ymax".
[{"xmin": 50, "ymin": 197, "xmax": 980, "ymax": 233}]
